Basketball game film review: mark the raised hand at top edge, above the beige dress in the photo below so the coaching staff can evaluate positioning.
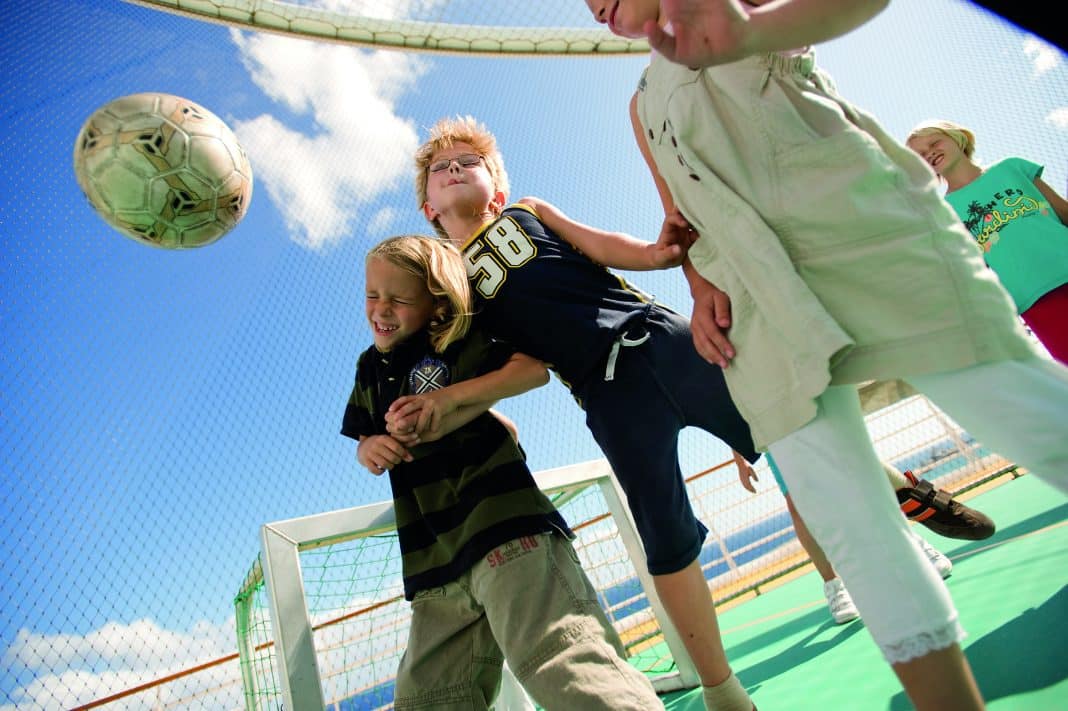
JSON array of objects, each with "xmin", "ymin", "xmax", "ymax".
[{"xmin": 642, "ymin": 0, "xmax": 749, "ymax": 67}]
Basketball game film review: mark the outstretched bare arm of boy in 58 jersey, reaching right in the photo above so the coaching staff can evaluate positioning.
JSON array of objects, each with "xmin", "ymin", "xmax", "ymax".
[{"xmin": 519, "ymin": 198, "xmax": 693, "ymax": 271}]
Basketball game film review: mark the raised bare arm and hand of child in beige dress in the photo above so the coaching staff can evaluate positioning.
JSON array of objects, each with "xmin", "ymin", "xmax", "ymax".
[{"xmin": 643, "ymin": 0, "xmax": 890, "ymax": 66}]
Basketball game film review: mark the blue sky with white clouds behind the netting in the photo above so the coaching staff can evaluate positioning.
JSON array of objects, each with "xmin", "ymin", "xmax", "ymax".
[{"xmin": 0, "ymin": 0, "xmax": 1068, "ymax": 708}]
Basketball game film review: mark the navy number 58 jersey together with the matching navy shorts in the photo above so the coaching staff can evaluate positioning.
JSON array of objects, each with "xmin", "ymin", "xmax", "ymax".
[{"xmin": 454, "ymin": 205, "xmax": 760, "ymax": 575}]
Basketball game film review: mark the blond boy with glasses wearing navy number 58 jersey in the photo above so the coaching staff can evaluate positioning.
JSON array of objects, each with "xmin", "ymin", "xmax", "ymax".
[{"xmin": 396, "ymin": 116, "xmax": 760, "ymax": 704}]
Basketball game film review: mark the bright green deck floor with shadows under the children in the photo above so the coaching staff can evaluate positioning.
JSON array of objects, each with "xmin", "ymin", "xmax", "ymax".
[{"xmin": 663, "ymin": 475, "xmax": 1068, "ymax": 711}]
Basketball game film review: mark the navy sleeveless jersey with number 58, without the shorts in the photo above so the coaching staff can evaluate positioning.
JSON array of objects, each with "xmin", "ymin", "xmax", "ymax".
[{"xmin": 462, "ymin": 205, "xmax": 653, "ymax": 389}]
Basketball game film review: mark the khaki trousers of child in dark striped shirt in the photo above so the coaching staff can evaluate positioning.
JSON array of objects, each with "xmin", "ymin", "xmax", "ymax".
[{"xmin": 394, "ymin": 534, "xmax": 663, "ymax": 711}]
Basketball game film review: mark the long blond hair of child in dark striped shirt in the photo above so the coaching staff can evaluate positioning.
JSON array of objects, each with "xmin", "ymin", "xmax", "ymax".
[{"xmin": 366, "ymin": 235, "xmax": 473, "ymax": 353}]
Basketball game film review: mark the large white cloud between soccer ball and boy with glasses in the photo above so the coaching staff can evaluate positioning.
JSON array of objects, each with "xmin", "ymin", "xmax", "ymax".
[{"xmin": 231, "ymin": 30, "xmax": 428, "ymax": 250}]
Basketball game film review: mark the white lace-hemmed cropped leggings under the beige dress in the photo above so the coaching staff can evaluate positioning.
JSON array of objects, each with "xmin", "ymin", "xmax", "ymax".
[{"xmin": 769, "ymin": 358, "xmax": 1068, "ymax": 664}]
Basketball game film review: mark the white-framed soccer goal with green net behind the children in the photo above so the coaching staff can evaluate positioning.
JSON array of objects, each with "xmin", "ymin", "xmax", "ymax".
[{"xmin": 235, "ymin": 460, "xmax": 717, "ymax": 711}]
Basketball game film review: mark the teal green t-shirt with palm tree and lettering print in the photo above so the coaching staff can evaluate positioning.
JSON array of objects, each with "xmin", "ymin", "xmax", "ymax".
[{"xmin": 945, "ymin": 158, "xmax": 1068, "ymax": 314}]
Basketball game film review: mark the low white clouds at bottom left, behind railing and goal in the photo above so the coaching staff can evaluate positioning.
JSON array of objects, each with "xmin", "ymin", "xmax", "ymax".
[{"xmin": 0, "ymin": 589, "xmax": 410, "ymax": 711}]
